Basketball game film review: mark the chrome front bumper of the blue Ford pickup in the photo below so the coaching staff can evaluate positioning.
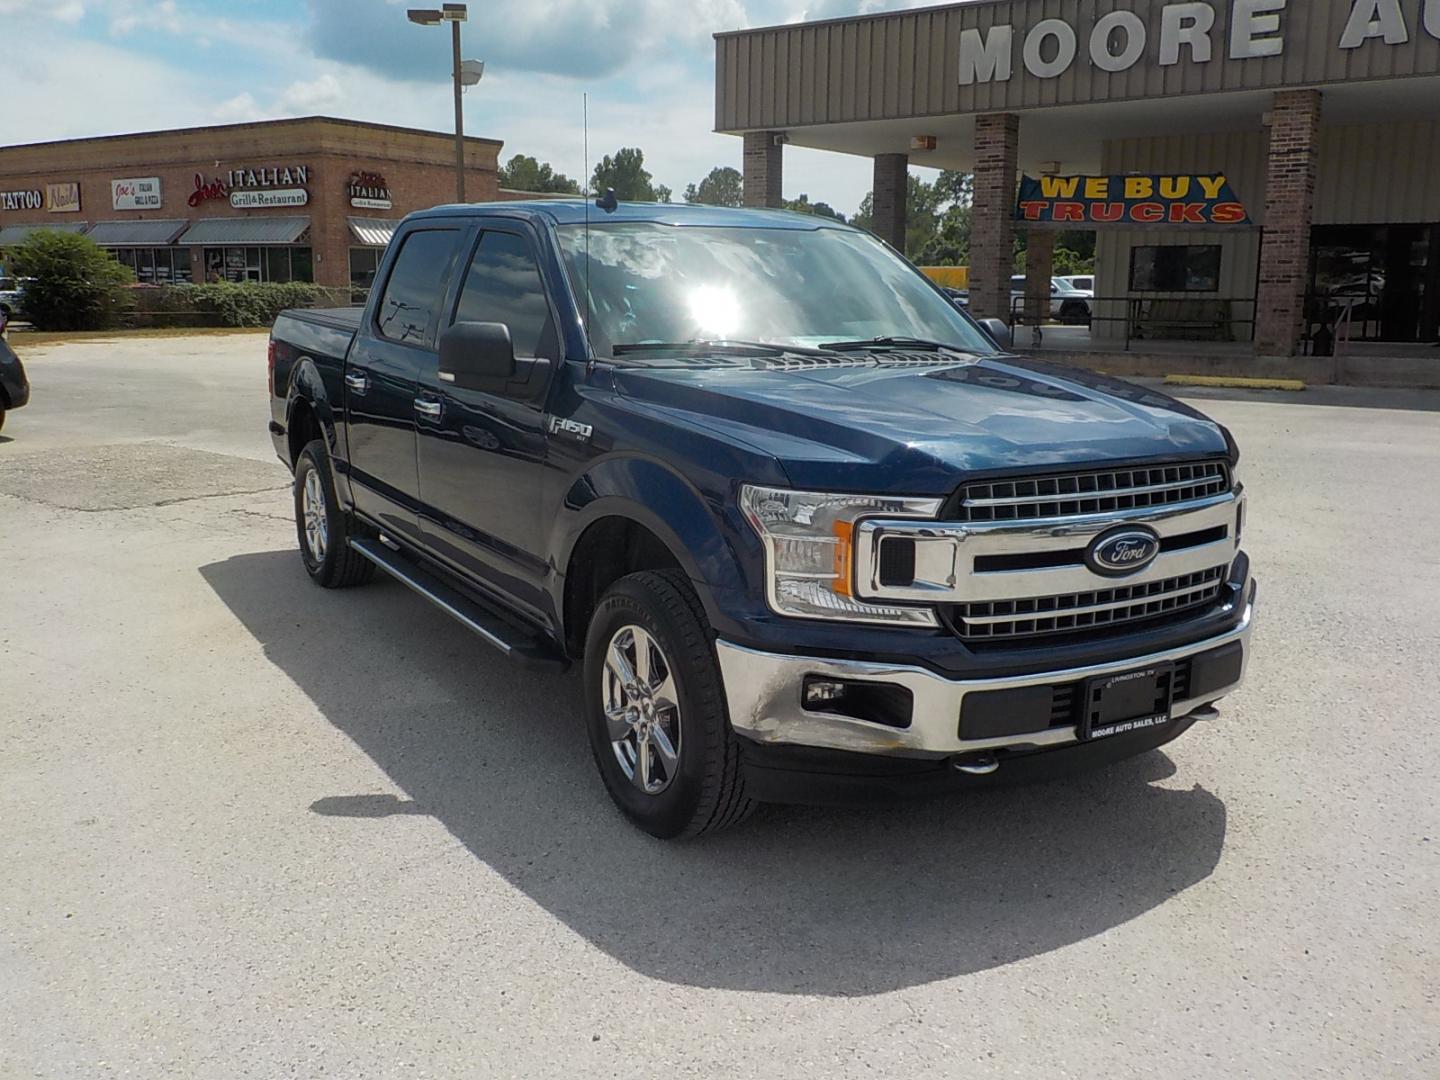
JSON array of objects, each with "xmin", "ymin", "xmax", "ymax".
[{"xmin": 716, "ymin": 593, "xmax": 1254, "ymax": 756}]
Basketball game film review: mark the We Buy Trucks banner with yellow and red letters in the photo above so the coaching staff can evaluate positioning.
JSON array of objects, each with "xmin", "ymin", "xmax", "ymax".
[{"xmin": 1015, "ymin": 176, "xmax": 1253, "ymax": 228}]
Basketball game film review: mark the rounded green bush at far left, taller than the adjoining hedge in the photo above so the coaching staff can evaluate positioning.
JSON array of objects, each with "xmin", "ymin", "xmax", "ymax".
[{"xmin": 10, "ymin": 229, "xmax": 135, "ymax": 330}]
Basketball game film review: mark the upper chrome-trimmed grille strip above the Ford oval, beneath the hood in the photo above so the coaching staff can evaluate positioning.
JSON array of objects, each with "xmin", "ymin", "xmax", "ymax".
[{"xmin": 955, "ymin": 461, "xmax": 1230, "ymax": 521}]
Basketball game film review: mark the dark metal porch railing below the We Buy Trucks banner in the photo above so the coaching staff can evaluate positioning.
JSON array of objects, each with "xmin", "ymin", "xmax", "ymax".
[{"xmin": 1008, "ymin": 294, "xmax": 1256, "ymax": 351}]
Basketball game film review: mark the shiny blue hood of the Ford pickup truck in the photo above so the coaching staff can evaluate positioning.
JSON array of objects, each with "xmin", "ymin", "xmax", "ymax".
[{"xmin": 615, "ymin": 354, "xmax": 1228, "ymax": 494}]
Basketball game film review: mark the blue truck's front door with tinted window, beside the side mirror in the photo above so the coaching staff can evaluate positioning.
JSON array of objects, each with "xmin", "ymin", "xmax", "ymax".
[{"xmin": 419, "ymin": 220, "xmax": 560, "ymax": 621}]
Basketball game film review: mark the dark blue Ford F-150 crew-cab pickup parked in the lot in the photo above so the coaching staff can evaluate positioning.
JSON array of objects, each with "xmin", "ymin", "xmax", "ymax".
[{"xmin": 269, "ymin": 200, "xmax": 1256, "ymax": 837}]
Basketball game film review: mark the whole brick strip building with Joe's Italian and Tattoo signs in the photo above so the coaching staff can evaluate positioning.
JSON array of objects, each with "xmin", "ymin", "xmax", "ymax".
[{"xmin": 0, "ymin": 117, "xmax": 503, "ymax": 288}]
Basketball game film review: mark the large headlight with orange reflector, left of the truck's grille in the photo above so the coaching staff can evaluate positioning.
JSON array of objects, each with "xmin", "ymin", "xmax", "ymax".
[{"xmin": 740, "ymin": 484, "xmax": 942, "ymax": 626}]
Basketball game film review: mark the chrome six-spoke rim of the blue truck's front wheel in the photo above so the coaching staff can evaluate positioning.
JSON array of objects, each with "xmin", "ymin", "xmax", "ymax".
[{"xmin": 602, "ymin": 625, "xmax": 680, "ymax": 795}]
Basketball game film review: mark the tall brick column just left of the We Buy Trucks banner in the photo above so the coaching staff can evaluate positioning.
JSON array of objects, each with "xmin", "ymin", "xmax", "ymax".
[{"xmin": 971, "ymin": 112, "xmax": 1020, "ymax": 320}]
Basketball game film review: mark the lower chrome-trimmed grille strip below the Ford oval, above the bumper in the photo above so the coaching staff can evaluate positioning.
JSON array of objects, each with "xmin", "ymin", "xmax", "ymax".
[{"xmin": 953, "ymin": 564, "xmax": 1230, "ymax": 641}]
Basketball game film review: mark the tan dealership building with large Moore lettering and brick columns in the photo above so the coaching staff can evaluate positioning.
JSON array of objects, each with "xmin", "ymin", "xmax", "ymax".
[{"xmin": 716, "ymin": 0, "xmax": 1440, "ymax": 379}]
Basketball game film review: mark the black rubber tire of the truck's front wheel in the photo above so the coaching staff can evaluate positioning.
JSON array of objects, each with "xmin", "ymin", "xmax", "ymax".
[{"xmin": 585, "ymin": 570, "xmax": 755, "ymax": 840}]
